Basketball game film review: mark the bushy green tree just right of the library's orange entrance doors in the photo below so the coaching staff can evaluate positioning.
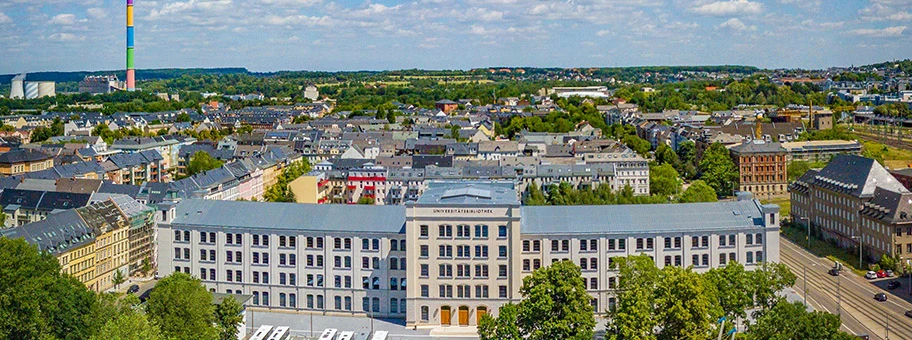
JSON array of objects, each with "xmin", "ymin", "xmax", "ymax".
[{"xmin": 478, "ymin": 261, "xmax": 595, "ymax": 340}]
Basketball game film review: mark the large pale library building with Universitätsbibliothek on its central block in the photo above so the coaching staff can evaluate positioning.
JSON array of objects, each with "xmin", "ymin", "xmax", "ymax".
[{"xmin": 157, "ymin": 182, "xmax": 779, "ymax": 327}]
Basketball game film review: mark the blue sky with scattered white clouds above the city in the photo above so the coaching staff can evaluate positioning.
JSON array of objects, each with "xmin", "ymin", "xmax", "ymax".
[{"xmin": 0, "ymin": 0, "xmax": 912, "ymax": 73}]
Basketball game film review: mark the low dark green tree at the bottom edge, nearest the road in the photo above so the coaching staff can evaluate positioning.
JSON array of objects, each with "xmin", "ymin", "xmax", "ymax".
[{"xmin": 748, "ymin": 299, "xmax": 855, "ymax": 340}]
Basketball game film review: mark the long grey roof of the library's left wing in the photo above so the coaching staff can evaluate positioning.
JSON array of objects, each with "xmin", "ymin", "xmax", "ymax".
[{"xmin": 172, "ymin": 199, "xmax": 405, "ymax": 233}]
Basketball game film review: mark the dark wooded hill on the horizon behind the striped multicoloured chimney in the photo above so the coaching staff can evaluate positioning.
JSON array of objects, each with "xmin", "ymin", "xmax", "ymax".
[{"xmin": 0, "ymin": 67, "xmax": 250, "ymax": 84}]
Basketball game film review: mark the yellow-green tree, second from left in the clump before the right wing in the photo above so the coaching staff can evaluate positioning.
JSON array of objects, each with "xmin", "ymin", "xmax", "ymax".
[{"xmin": 656, "ymin": 266, "xmax": 722, "ymax": 339}]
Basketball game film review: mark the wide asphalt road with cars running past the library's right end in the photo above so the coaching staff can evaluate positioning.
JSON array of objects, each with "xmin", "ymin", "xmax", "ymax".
[{"xmin": 779, "ymin": 237, "xmax": 912, "ymax": 339}]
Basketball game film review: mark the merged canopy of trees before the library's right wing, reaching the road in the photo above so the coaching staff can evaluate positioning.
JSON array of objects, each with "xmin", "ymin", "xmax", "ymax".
[{"xmin": 606, "ymin": 254, "xmax": 844, "ymax": 340}]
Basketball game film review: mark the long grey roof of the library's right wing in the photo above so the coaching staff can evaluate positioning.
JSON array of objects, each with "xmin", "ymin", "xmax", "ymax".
[{"xmin": 521, "ymin": 200, "xmax": 764, "ymax": 234}]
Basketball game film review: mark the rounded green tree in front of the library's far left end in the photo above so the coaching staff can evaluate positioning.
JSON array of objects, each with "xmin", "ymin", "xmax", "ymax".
[{"xmin": 146, "ymin": 273, "xmax": 218, "ymax": 339}]
